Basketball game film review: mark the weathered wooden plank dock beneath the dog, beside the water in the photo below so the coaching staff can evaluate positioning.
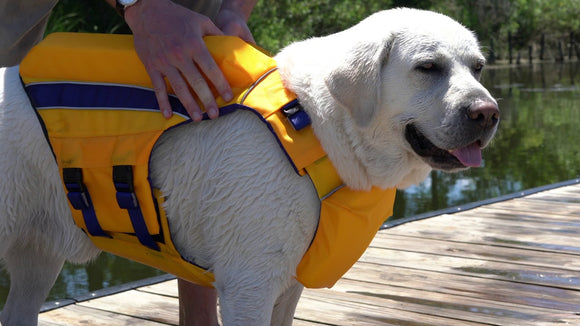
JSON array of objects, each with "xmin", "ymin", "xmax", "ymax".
[{"xmin": 40, "ymin": 180, "xmax": 580, "ymax": 326}]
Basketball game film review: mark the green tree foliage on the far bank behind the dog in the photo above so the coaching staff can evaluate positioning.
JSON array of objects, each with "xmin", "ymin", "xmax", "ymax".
[{"xmin": 47, "ymin": 0, "xmax": 580, "ymax": 52}]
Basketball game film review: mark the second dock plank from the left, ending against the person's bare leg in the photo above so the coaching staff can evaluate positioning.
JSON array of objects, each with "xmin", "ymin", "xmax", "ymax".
[{"xmin": 77, "ymin": 290, "xmax": 179, "ymax": 325}]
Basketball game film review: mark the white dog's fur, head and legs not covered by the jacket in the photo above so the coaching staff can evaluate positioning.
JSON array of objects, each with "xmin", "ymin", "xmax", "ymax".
[{"xmin": 0, "ymin": 9, "xmax": 499, "ymax": 326}]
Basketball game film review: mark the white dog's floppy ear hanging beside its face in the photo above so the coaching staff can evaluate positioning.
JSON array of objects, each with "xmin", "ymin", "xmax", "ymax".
[{"xmin": 325, "ymin": 40, "xmax": 392, "ymax": 127}]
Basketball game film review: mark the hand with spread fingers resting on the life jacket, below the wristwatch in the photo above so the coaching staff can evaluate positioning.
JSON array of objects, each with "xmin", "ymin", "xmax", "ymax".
[{"xmin": 125, "ymin": 0, "xmax": 231, "ymax": 121}]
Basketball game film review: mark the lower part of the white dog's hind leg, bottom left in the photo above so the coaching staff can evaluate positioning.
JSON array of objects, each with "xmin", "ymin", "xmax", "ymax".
[{"xmin": 0, "ymin": 231, "xmax": 65, "ymax": 326}]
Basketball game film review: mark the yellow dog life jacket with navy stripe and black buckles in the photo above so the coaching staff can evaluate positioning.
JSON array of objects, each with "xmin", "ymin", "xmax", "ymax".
[{"xmin": 20, "ymin": 33, "xmax": 395, "ymax": 288}]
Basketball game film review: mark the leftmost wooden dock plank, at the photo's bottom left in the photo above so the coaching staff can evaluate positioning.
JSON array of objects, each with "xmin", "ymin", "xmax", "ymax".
[{"xmin": 38, "ymin": 303, "xmax": 168, "ymax": 326}]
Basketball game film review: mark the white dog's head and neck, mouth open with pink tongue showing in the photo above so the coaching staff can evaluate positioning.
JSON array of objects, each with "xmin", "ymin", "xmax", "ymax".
[{"xmin": 277, "ymin": 9, "xmax": 499, "ymax": 189}]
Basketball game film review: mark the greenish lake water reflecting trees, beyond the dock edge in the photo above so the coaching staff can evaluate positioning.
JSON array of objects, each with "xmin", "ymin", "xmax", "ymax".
[{"xmin": 0, "ymin": 63, "xmax": 580, "ymax": 305}]
